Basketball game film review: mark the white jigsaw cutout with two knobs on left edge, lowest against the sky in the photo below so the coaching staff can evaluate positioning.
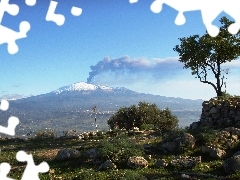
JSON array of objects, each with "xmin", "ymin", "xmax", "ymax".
[{"xmin": 0, "ymin": 21, "xmax": 30, "ymax": 54}]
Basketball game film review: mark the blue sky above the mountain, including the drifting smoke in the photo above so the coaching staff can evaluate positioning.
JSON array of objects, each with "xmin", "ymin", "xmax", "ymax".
[{"xmin": 0, "ymin": 0, "xmax": 240, "ymax": 99}]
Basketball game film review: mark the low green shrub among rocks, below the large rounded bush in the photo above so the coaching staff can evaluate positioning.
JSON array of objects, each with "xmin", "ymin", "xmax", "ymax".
[{"xmin": 99, "ymin": 135, "xmax": 143, "ymax": 164}]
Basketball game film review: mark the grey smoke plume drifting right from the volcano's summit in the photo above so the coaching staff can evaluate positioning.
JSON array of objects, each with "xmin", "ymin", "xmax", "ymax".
[{"xmin": 87, "ymin": 56, "xmax": 183, "ymax": 83}]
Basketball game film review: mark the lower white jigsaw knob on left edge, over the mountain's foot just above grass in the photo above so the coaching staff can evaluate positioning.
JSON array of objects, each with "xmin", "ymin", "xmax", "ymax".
[{"xmin": 0, "ymin": 116, "xmax": 19, "ymax": 136}]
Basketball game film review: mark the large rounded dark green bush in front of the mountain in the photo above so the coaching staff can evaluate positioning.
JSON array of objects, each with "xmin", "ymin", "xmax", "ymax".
[{"xmin": 108, "ymin": 102, "xmax": 178, "ymax": 130}]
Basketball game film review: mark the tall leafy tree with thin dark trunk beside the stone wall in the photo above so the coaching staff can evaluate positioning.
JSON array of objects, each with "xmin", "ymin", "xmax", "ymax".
[{"xmin": 173, "ymin": 17, "xmax": 240, "ymax": 97}]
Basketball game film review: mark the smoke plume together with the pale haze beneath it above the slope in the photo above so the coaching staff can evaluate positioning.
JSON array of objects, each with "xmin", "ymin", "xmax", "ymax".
[{"xmin": 89, "ymin": 56, "xmax": 240, "ymax": 100}]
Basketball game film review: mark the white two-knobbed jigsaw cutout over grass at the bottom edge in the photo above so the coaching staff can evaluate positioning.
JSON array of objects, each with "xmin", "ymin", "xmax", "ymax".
[{"xmin": 16, "ymin": 151, "xmax": 50, "ymax": 180}]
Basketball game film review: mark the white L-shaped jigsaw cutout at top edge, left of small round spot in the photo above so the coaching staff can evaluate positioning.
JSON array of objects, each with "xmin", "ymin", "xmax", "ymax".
[{"xmin": 46, "ymin": 1, "xmax": 65, "ymax": 26}]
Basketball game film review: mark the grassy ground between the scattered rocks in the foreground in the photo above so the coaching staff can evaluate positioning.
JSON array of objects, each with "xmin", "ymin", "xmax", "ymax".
[{"xmin": 0, "ymin": 131, "xmax": 240, "ymax": 180}]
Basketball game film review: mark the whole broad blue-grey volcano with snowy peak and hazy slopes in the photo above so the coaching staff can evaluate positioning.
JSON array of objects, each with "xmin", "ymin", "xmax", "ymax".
[{"xmin": 0, "ymin": 82, "xmax": 203, "ymax": 134}]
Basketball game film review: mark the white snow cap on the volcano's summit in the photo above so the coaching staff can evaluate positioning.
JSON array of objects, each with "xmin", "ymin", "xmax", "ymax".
[{"xmin": 54, "ymin": 82, "xmax": 113, "ymax": 94}]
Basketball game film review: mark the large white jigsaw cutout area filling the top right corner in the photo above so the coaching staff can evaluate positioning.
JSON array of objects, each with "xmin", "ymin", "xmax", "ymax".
[{"xmin": 129, "ymin": 0, "xmax": 240, "ymax": 37}]
